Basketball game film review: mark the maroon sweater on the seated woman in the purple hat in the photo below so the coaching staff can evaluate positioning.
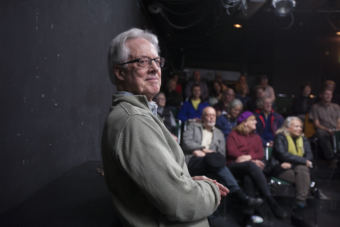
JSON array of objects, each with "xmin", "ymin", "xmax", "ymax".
[{"xmin": 227, "ymin": 130, "xmax": 264, "ymax": 163}]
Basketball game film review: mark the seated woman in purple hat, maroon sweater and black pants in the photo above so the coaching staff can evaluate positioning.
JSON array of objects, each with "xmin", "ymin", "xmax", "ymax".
[{"xmin": 227, "ymin": 111, "xmax": 287, "ymax": 218}]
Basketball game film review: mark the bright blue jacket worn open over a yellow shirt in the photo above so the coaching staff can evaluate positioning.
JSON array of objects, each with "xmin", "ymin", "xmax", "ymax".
[{"xmin": 177, "ymin": 100, "xmax": 209, "ymax": 122}]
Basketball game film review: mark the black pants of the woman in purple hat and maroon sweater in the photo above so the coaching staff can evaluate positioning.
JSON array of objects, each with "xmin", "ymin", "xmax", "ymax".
[{"xmin": 229, "ymin": 161, "xmax": 271, "ymax": 198}]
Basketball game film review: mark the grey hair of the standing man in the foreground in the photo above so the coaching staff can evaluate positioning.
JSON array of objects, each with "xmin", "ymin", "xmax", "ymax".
[{"xmin": 108, "ymin": 28, "xmax": 160, "ymax": 84}]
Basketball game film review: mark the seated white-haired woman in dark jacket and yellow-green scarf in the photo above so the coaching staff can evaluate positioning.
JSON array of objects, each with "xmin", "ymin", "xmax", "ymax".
[{"xmin": 270, "ymin": 117, "xmax": 313, "ymax": 208}]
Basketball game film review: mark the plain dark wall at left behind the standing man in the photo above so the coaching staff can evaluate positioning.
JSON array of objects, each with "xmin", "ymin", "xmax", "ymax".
[{"xmin": 0, "ymin": 0, "xmax": 144, "ymax": 212}]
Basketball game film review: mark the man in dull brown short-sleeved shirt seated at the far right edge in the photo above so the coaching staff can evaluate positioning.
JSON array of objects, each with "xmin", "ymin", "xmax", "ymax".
[{"xmin": 309, "ymin": 89, "xmax": 340, "ymax": 160}]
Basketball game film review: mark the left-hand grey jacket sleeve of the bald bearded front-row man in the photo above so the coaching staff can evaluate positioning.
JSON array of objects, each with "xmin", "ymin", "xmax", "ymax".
[{"xmin": 182, "ymin": 123, "xmax": 203, "ymax": 154}]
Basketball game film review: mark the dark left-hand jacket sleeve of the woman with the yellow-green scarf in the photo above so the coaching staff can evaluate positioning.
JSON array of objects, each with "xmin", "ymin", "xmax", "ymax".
[{"xmin": 273, "ymin": 134, "xmax": 307, "ymax": 164}]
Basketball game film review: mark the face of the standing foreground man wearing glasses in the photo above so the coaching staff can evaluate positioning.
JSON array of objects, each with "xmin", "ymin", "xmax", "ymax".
[{"xmin": 118, "ymin": 38, "xmax": 161, "ymax": 101}]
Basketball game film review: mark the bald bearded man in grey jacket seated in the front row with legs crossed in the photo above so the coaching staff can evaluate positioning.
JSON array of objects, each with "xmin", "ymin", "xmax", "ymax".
[{"xmin": 182, "ymin": 107, "xmax": 262, "ymax": 206}]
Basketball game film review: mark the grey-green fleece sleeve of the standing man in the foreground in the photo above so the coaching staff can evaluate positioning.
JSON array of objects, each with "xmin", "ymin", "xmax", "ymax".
[{"xmin": 115, "ymin": 116, "xmax": 220, "ymax": 222}]
